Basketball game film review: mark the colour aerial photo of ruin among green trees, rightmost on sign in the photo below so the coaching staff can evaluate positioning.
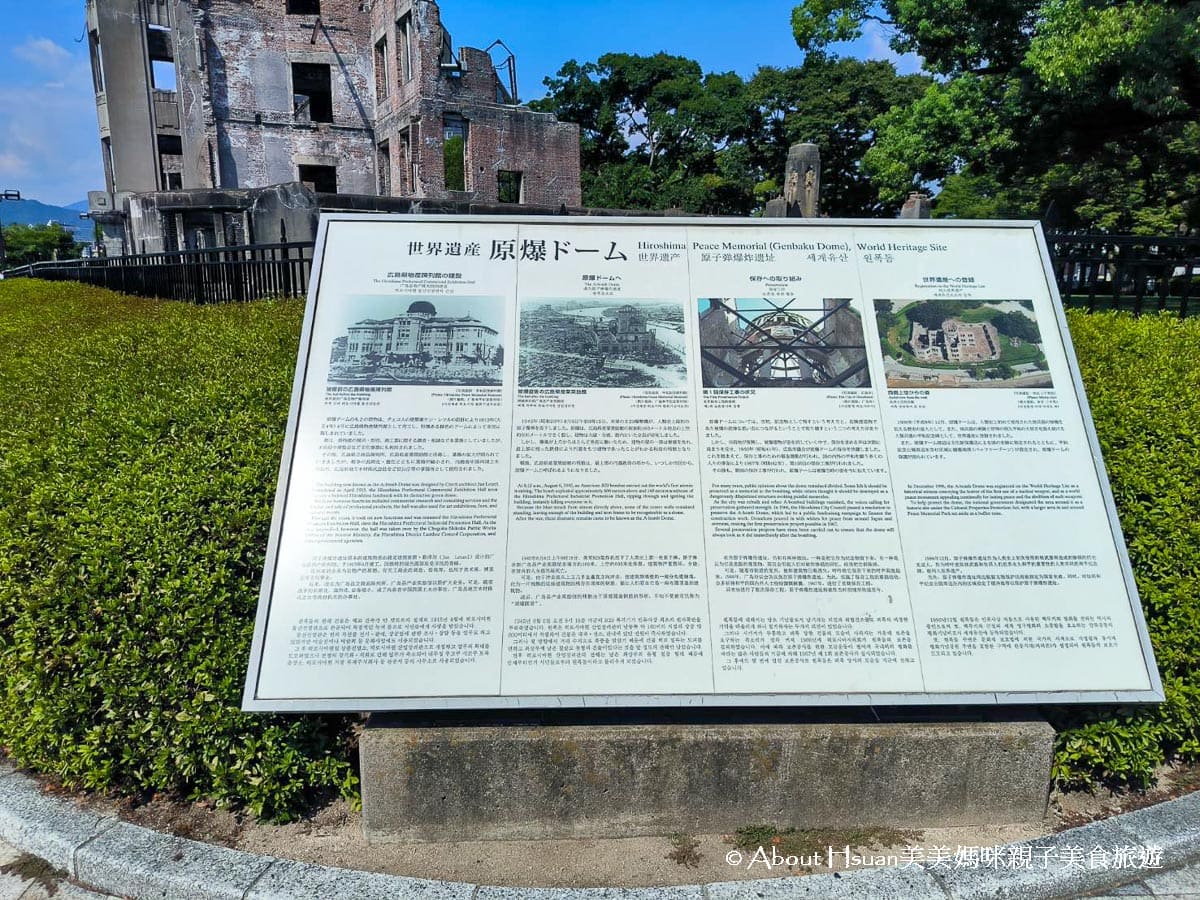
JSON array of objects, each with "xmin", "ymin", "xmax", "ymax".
[{"xmin": 875, "ymin": 299, "xmax": 1054, "ymax": 388}]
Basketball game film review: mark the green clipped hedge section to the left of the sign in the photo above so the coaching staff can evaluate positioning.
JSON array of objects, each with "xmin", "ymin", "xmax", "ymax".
[{"xmin": 0, "ymin": 280, "xmax": 356, "ymax": 820}]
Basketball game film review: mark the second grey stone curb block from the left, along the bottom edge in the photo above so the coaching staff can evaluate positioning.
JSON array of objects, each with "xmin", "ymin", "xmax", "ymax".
[{"xmin": 76, "ymin": 822, "xmax": 271, "ymax": 900}]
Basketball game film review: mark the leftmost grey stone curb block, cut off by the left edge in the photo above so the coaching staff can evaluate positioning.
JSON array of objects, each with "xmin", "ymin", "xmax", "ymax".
[{"xmin": 0, "ymin": 778, "xmax": 116, "ymax": 874}]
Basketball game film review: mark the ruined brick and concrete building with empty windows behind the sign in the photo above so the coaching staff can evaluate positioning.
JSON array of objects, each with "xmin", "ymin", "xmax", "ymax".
[{"xmin": 86, "ymin": 0, "xmax": 580, "ymax": 252}]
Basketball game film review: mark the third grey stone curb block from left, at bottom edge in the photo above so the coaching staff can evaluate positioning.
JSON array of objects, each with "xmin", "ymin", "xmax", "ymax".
[{"xmin": 246, "ymin": 859, "xmax": 475, "ymax": 900}]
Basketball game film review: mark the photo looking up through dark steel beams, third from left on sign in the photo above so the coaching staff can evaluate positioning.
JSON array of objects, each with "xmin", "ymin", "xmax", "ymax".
[{"xmin": 700, "ymin": 298, "xmax": 871, "ymax": 388}]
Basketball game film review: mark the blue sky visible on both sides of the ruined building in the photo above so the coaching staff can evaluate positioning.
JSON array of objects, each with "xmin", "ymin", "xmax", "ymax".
[{"xmin": 0, "ymin": 0, "xmax": 917, "ymax": 206}]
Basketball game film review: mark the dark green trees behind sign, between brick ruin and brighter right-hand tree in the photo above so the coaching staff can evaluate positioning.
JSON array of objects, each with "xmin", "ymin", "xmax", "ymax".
[{"xmin": 532, "ymin": 53, "xmax": 931, "ymax": 216}]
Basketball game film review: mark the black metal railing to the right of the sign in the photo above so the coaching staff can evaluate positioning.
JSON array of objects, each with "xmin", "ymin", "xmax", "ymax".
[{"xmin": 1046, "ymin": 234, "xmax": 1200, "ymax": 317}]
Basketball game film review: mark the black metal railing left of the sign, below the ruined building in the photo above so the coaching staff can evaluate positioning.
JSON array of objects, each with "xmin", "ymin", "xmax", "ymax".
[{"xmin": 5, "ymin": 242, "xmax": 313, "ymax": 304}]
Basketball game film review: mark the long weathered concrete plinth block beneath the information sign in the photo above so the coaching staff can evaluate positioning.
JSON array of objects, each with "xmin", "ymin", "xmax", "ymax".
[{"xmin": 360, "ymin": 720, "xmax": 1054, "ymax": 841}]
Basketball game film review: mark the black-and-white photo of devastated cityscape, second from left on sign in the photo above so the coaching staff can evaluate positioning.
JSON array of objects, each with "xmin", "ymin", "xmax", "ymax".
[{"xmin": 517, "ymin": 299, "xmax": 688, "ymax": 388}]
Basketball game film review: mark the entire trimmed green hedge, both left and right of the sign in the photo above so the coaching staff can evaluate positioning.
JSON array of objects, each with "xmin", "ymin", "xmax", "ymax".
[{"xmin": 0, "ymin": 281, "xmax": 1200, "ymax": 820}]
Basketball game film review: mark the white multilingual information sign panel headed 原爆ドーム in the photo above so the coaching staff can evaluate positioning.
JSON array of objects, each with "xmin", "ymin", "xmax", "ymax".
[{"xmin": 245, "ymin": 216, "xmax": 1163, "ymax": 710}]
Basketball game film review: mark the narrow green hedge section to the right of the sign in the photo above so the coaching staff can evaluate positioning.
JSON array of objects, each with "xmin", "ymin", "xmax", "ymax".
[{"xmin": 1051, "ymin": 311, "xmax": 1200, "ymax": 786}]
